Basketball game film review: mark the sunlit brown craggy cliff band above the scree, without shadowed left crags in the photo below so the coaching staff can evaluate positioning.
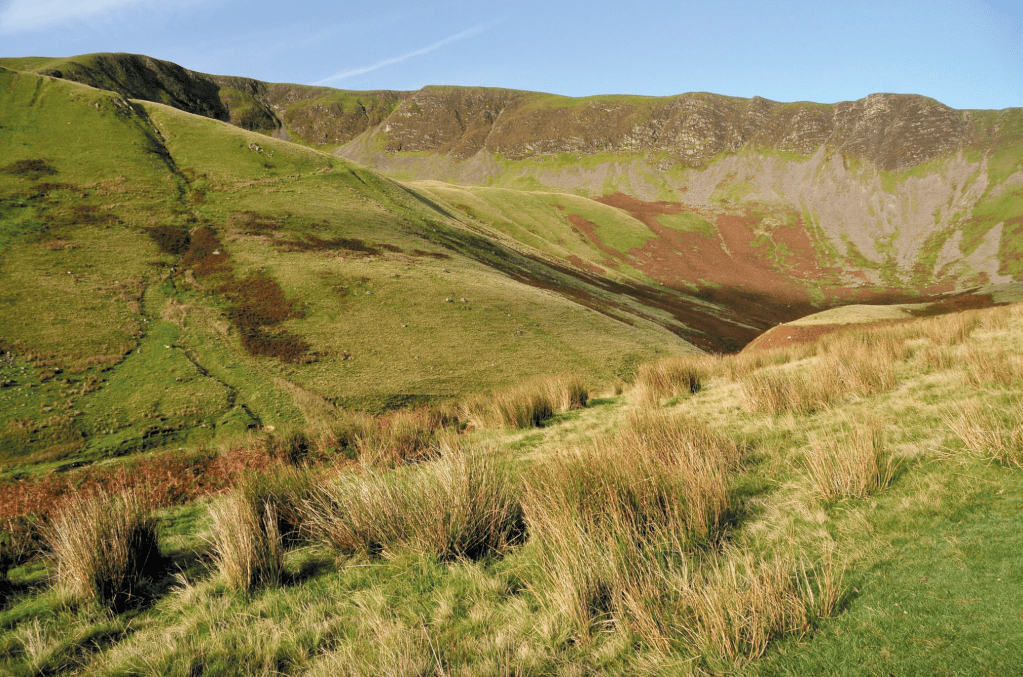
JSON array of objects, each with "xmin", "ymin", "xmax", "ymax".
[{"xmin": 366, "ymin": 88, "xmax": 969, "ymax": 170}]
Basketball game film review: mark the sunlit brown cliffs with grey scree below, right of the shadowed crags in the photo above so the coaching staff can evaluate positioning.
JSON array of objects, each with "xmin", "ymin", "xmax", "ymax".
[{"xmin": 338, "ymin": 89, "xmax": 1023, "ymax": 292}]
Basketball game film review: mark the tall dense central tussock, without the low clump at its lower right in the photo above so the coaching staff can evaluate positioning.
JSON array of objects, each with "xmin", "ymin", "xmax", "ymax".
[{"xmin": 525, "ymin": 414, "xmax": 739, "ymax": 635}]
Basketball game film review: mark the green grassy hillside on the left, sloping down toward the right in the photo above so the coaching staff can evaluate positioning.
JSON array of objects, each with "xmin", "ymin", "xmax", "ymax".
[{"xmin": 0, "ymin": 64, "xmax": 693, "ymax": 472}]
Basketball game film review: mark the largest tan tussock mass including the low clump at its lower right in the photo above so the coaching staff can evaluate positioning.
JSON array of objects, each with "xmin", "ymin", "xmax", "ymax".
[{"xmin": 525, "ymin": 412, "xmax": 843, "ymax": 671}]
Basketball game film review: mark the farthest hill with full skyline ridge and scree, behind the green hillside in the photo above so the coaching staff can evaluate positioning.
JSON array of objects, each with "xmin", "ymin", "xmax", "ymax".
[{"xmin": 0, "ymin": 54, "xmax": 1023, "ymax": 303}]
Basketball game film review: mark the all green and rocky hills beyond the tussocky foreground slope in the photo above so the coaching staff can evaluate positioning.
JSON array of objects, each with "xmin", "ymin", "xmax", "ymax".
[{"xmin": 0, "ymin": 54, "xmax": 1023, "ymax": 472}]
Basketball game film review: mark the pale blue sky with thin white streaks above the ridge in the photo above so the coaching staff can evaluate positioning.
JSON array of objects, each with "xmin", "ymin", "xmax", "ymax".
[{"xmin": 0, "ymin": 0, "xmax": 1023, "ymax": 108}]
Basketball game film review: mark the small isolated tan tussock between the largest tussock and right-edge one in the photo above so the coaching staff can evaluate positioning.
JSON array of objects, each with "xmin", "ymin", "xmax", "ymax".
[{"xmin": 805, "ymin": 419, "xmax": 898, "ymax": 501}]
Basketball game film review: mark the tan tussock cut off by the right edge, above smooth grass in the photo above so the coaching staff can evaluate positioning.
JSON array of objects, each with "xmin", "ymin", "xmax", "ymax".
[{"xmin": 942, "ymin": 401, "xmax": 1023, "ymax": 467}]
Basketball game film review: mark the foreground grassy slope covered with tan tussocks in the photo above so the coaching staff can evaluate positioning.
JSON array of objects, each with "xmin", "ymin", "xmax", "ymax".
[{"xmin": 0, "ymin": 305, "xmax": 1023, "ymax": 675}]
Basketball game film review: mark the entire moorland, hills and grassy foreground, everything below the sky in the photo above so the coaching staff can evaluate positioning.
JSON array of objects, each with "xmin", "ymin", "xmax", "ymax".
[{"xmin": 0, "ymin": 54, "xmax": 1023, "ymax": 675}]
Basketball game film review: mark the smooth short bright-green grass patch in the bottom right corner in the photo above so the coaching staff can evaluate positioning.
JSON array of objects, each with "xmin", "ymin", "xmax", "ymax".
[{"xmin": 757, "ymin": 466, "xmax": 1023, "ymax": 676}]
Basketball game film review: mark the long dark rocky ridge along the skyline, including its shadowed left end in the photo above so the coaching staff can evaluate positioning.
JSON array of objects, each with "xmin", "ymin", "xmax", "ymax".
[{"xmin": 0, "ymin": 53, "xmax": 1012, "ymax": 170}]
